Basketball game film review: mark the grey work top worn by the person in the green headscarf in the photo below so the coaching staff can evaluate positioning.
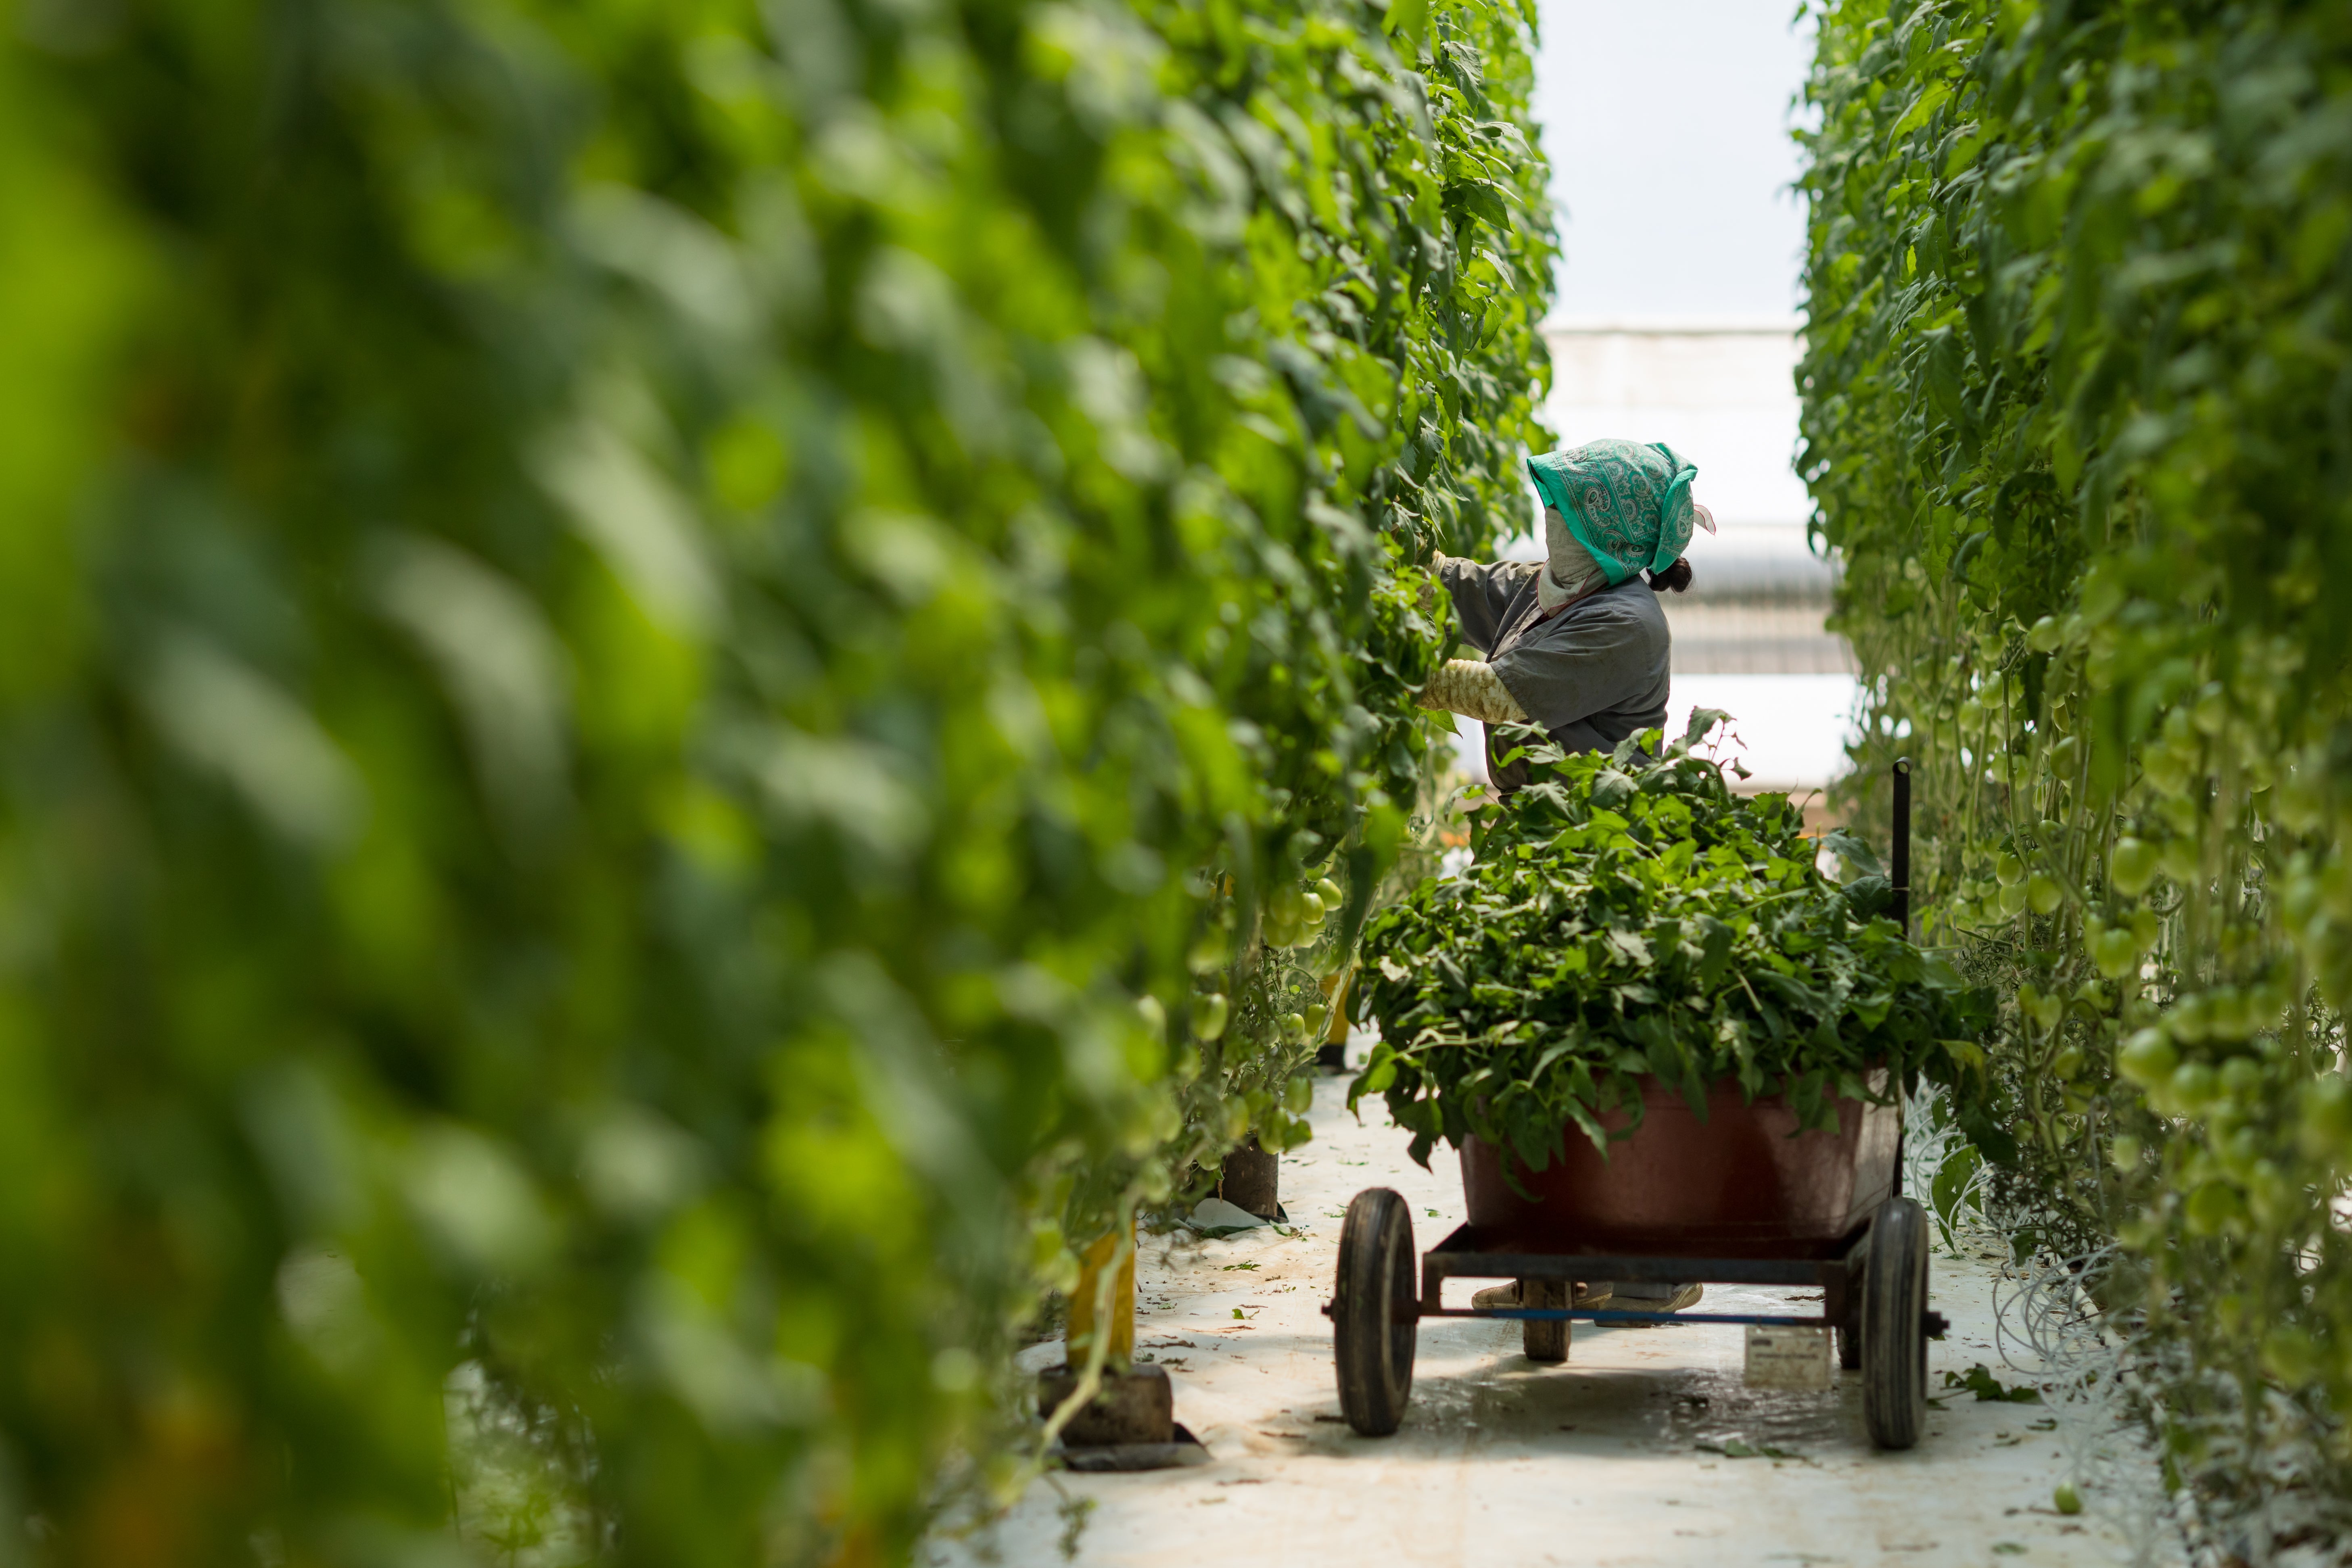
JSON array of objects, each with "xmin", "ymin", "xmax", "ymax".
[{"xmin": 1435, "ymin": 555, "xmax": 1672, "ymax": 790}]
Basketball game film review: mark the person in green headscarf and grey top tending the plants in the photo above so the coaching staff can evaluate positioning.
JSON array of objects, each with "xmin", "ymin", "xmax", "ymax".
[{"xmin": 1420, "ymin": 440, "xmax": 1715, "ymax": 790}]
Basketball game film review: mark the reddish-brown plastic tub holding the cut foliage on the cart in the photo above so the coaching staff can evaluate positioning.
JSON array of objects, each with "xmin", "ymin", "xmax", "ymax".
[{"xmin": 1460, "ymin": 1074, "xmax": 1903, "ymax": 1258}]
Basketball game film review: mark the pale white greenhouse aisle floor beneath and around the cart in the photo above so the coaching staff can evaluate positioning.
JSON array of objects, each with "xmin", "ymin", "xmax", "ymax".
[{"xmin": 920, "ymin": 1079, "xmax": 2164, "ymax": 1568}]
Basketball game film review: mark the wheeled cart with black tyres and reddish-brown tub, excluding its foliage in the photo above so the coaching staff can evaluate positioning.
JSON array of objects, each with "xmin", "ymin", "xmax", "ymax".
[{"xmin": 1324, "ymin": 1079, "xmax": 1945, "ymax": 1448}]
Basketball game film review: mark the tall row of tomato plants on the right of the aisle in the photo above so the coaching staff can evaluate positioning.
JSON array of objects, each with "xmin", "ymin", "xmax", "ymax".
[{"xmin": 1799, "ymin": 0, "xmax": 2352, "ymax": 1561}]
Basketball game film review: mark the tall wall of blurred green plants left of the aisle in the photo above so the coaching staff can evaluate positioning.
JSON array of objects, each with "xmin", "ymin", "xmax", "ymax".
[{"xmin": 0, "ymin": 0, "xmax": 1552, "ymax": 1568}]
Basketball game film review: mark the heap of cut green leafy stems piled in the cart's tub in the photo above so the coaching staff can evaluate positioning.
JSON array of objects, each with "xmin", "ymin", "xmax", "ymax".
[{"xmin": 1350, "ymin": 710, "xmax": 1990, "ymax": 1171}]
